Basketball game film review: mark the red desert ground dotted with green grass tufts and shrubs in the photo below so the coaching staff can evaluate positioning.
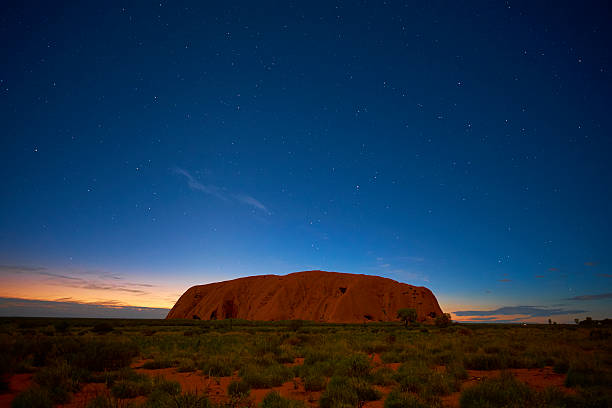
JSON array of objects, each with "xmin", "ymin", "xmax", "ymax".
[{"xmin": 0, "ymin": 318, "xmax": 612, "ymax": 408}]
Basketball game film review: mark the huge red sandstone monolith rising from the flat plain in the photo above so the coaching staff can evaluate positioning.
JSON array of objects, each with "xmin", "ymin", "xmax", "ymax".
[{"xmin": 167, "ymin": 271, "xmax": 442, "ymax": 323}]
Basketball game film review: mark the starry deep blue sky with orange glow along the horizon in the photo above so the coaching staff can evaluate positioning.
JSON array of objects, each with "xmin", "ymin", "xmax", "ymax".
[{"xmin": 0, "ymin": 1, "xmax": 612, "ymax": 323}]
